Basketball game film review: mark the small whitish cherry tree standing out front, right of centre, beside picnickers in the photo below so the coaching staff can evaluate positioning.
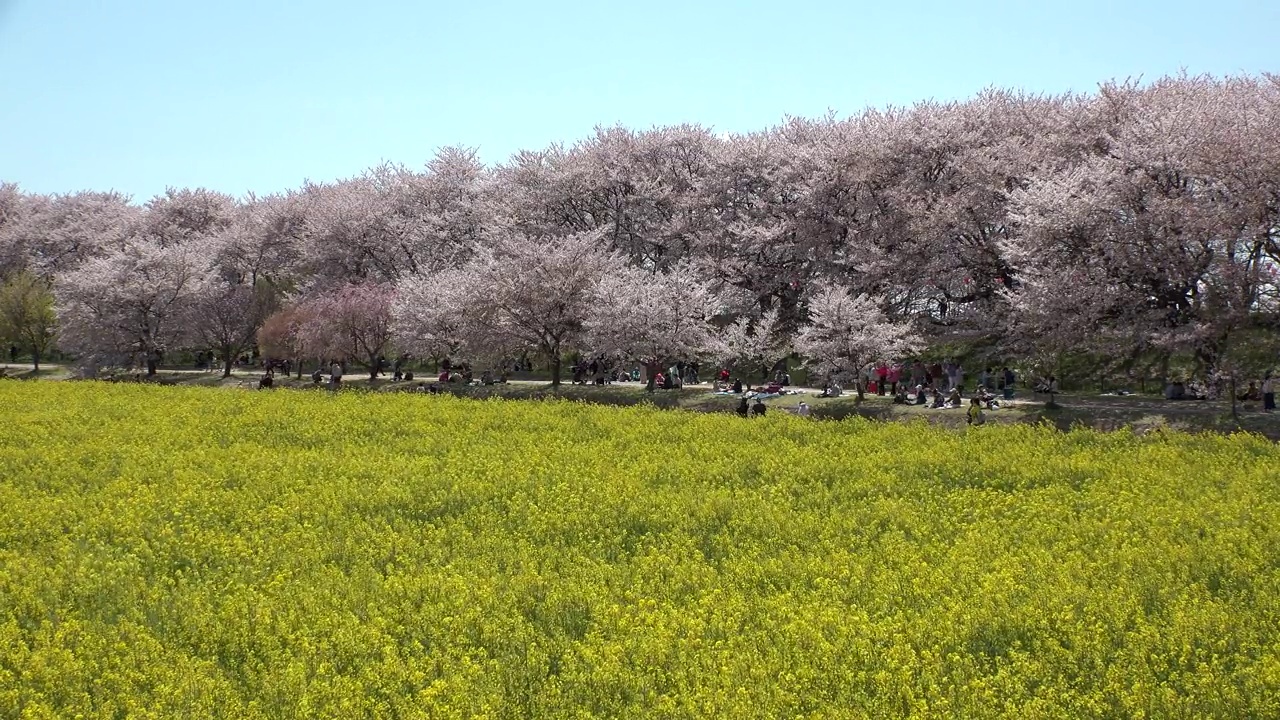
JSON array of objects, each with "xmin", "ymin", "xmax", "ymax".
[{"xmin": 795, "ymin": 282, "xmax": 923, "ymax": 400}]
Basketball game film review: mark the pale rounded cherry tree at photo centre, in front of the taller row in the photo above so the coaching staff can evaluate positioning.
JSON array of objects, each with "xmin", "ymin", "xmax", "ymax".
[{"xmin": 585, "ymin": 264, "xmax": 726, "ymax": 391}]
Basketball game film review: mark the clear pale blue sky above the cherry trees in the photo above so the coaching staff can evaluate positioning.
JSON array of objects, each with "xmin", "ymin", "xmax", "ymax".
[{"xmin": 0, "ymin": 0, "xmax": 1280, "ymax": 201}]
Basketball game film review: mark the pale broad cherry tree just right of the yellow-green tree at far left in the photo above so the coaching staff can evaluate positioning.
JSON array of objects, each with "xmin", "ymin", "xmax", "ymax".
[{"xmin": 54, "ymin": 238, "xmax": 202, "ymax": 375}]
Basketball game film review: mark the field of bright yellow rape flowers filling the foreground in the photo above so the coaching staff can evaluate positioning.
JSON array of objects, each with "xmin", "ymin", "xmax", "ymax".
[{"xmin": 0, "ymin": 380, "xmax": 1280, "ymax": 719}]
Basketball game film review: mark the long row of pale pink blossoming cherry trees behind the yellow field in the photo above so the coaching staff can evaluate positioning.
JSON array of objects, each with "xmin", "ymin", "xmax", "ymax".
[{"xmin": 0, "ymin": 76, "xmax": 1280, "ymax": 386}]
